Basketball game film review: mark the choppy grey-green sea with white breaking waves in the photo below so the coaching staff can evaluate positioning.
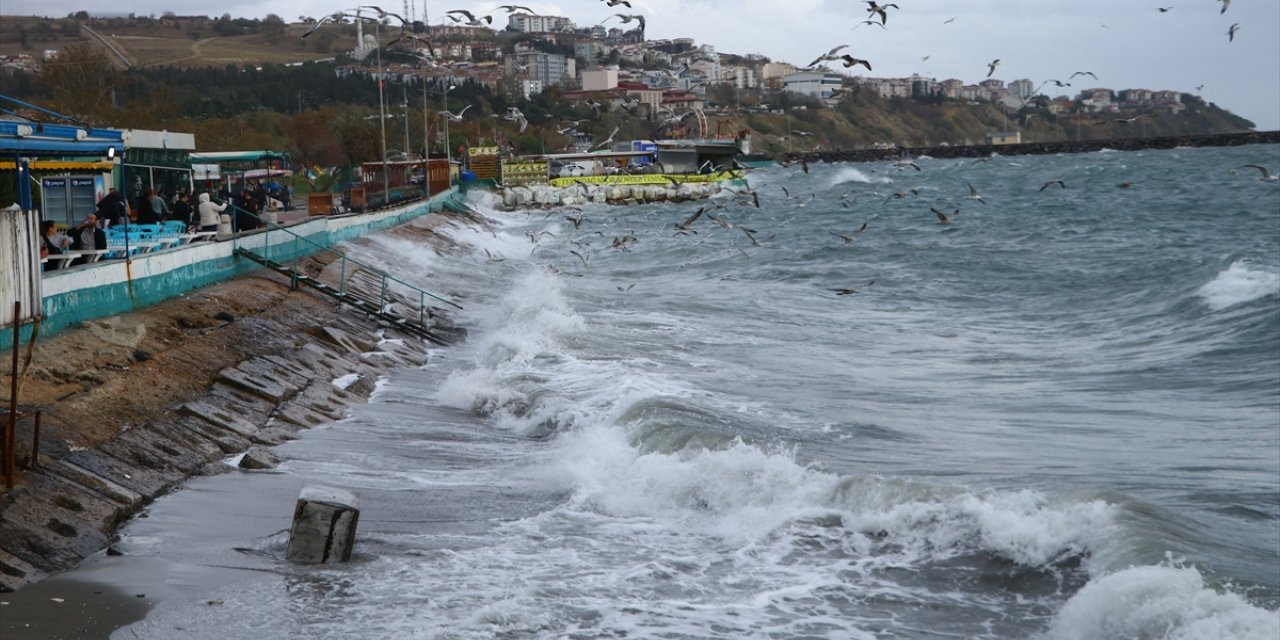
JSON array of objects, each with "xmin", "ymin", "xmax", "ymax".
[{"xmin": 10, "ymin": 146, "xmax": 1280, "ymax": 640}]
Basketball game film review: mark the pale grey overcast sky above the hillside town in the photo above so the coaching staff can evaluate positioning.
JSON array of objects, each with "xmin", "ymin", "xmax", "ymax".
[{"xmin": 10, "ymin": 0, "xmax": 1280, "ymax": 131}]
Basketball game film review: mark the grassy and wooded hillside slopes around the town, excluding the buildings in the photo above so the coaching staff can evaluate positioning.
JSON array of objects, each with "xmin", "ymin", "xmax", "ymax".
[{"xmin": 0, "ymin": 15, "xmax": 1253, "ymax": 165}]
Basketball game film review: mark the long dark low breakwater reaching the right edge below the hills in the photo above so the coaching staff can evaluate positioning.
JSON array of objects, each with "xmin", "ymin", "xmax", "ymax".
[{"xmin": 781, "ymin": 131, "xmax": 1280, "ymax": 163}]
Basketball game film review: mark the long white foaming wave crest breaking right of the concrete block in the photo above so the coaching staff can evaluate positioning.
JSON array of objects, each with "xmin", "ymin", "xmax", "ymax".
[{"xmin": 562, "ymin": 429, "xmax": 1116, "ymax": 567}]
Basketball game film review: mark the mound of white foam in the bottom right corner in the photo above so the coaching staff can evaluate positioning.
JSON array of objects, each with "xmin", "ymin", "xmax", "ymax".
[{"xmin": 1044, "ymin": 564, "xmax": 1280, "ymax": 640}]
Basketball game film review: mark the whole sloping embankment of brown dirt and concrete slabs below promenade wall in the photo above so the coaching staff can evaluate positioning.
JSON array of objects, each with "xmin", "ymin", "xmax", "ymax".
[{"xmin": 0, "ymin": 212, "xmax": 474, "ymax": 593}]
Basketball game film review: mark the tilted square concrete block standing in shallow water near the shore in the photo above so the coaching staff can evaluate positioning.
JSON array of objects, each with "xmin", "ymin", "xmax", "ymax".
[{"xmin": 285, "ymin": 486, "xmax": 360, "ymax": 564}]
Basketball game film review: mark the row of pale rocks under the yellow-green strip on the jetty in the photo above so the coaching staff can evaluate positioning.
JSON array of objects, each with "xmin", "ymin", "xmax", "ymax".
[{"xmin": 502, "ymin": 182, "xmax": 723, "ymax": 210}]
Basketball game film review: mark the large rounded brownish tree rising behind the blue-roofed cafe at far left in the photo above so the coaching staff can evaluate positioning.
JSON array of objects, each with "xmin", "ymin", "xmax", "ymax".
[{"xmin": 37, "ymin": 45, "xmax": 122, "ymax": 123}]
